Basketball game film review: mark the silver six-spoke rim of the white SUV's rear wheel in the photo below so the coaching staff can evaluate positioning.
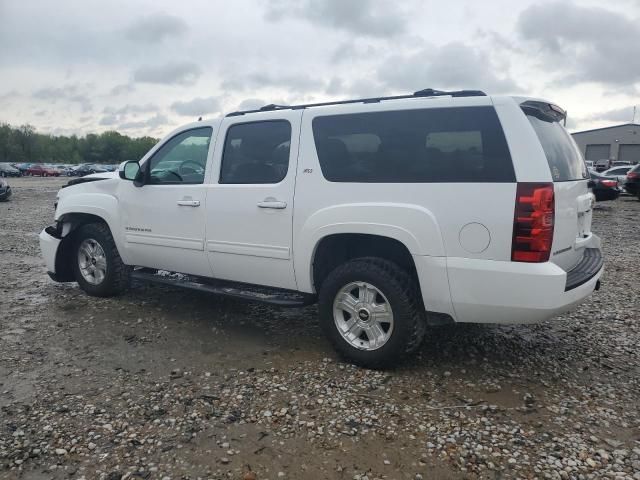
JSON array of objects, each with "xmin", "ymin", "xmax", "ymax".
[{"xmin": 333, "ymin": 282, "xmax": 393, "ymax": 351}]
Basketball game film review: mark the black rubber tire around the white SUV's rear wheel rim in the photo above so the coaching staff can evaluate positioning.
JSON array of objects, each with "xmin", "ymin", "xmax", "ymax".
[{"xmin": 318, "ymin": 257, "xmax": 426, "ymax": 369}]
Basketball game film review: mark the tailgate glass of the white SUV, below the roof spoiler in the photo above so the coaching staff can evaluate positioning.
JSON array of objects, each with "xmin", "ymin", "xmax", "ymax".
[{"xmin": 527, "ymin": 114, "xmax": 597, "ymax": 182}]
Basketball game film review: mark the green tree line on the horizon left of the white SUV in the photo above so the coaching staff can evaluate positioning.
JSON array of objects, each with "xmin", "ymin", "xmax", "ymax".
[{"xmin": 0, "ymin": 123, "xmax": 158, "ymax": 164}]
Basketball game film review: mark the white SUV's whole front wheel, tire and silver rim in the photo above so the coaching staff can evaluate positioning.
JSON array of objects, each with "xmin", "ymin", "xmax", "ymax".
[{"xmin": 72, "ymin": 223, "xmax": 131, "ymax": 297}]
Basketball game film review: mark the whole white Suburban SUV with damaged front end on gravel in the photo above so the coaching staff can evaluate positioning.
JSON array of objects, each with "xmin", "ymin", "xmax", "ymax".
[{"xmin": 40, "ymin": 89, "xmax": 603, "ymax": 367}]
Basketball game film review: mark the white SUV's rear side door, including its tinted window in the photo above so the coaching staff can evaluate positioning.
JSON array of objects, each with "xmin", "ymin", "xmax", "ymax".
[{"xmin": 206, "ymin": 110, "xmax": 302, "ymax": 289}]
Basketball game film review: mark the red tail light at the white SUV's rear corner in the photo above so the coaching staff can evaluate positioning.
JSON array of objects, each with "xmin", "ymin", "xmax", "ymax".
[{"xmin": 511, "ymin": 183, "xmax": 555, "ymax": 262}]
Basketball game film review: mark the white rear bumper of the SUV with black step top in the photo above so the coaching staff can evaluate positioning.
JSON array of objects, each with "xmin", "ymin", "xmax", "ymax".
[{"xmin": 447, "ymin": 242, "xmax": 603, "ymax": 324}]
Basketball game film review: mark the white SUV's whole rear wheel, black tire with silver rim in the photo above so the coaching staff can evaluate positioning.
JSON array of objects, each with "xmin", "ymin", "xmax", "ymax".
[{"xmin": 319, "ymin": 257, "xmax": 426, "ymax": 368}]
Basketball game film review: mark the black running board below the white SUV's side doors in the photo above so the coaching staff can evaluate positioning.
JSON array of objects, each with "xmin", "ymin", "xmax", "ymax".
[{"xmin": 131, "ymin": 269, "xmax": 316, "ymax": 307}]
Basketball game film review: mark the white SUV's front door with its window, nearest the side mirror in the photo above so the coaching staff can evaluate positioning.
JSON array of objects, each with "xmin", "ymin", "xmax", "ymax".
[{"xmin": 119, "ymin": 127, "xmax": 213, "ymax": 276}]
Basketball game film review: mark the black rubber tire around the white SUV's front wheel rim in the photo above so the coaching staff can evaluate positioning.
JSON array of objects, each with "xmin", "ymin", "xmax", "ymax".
[{"xmin": 71, "ymin": 223, "xmax": 131, "ymax": 297}]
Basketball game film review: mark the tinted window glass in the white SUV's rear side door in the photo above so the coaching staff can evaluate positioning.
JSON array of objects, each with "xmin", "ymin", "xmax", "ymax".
[{"xmin": 220, "ymin": 120, "xmax": 291, "ymax": 183}]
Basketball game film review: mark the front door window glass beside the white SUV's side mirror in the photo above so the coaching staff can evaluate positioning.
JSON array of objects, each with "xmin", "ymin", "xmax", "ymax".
[{"xmin": 148, "ymin": 127, "xmax": 213, "ymax": 185}]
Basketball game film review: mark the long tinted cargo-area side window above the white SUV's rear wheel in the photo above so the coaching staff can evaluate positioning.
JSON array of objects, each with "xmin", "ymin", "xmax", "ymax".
[{"xmin": 313, "ymin": 107, "xmax": 515, "ymax": 183}]
